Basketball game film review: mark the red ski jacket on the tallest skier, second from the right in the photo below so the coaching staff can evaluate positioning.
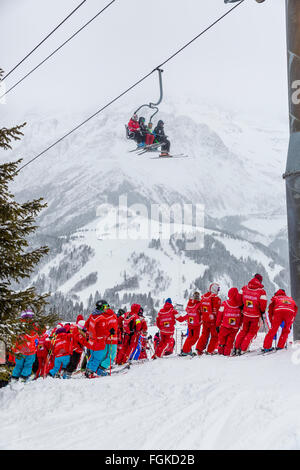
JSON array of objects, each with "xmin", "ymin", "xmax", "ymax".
[{"xmin": 240, "ymin": 277, "xmax": 267, "ymax": 318}]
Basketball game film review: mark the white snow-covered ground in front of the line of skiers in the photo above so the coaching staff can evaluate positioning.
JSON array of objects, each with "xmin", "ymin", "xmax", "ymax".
[{"xmin": 0, "ymin": 337, "xmax": 300, "ymax": 450}]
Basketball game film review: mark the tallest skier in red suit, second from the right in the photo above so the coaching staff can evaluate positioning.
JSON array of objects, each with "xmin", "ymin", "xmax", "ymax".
[{"xmin": 234, "ymin": 274, "xmax": 267, "ymax": 355}]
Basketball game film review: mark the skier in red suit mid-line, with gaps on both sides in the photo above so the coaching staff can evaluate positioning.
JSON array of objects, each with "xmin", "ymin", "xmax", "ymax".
[{"xmin": 152, "ymin": 298, "xmax": 180, "ymax": 359}]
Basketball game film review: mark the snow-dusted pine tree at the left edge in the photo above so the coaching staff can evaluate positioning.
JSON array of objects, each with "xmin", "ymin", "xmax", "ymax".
[{"xmin": 0, "ymin": 113, "xmax": 57, "ymax": 380}]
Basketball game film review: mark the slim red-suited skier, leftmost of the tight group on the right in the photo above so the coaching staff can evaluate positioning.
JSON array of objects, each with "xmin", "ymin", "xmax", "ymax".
[{"xmin": 177, "ymin": 292, "xmax": 201, "ymax": 356}]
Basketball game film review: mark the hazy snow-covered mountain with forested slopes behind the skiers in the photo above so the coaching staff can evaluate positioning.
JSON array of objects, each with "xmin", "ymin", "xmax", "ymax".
[{"xmin": 6, "ymin": 103, "xmax": 287, "ymax": 316}]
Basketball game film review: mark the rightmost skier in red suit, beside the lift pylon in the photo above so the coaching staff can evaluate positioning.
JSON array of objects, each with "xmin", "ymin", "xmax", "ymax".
[{"xmin": 263, "ymin": 289, "xmax": 298, "ymax": 351}]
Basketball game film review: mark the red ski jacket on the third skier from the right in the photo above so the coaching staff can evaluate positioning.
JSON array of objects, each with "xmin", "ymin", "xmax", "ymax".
[{"xmin": 216, "ymin": 287, "xmax": 243, "ymax": 330}]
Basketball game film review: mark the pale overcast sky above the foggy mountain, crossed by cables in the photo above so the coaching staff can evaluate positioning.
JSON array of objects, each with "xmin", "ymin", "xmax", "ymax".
[{"xmin": 0, "ymin": 0, "xmax": 288, "ymax": 125}]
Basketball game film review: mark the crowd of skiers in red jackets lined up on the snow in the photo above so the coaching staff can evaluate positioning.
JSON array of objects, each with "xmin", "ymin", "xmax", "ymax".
[{"xmin": 9, "ymin": 274, "xmax": 297, "ymax": 382}]
